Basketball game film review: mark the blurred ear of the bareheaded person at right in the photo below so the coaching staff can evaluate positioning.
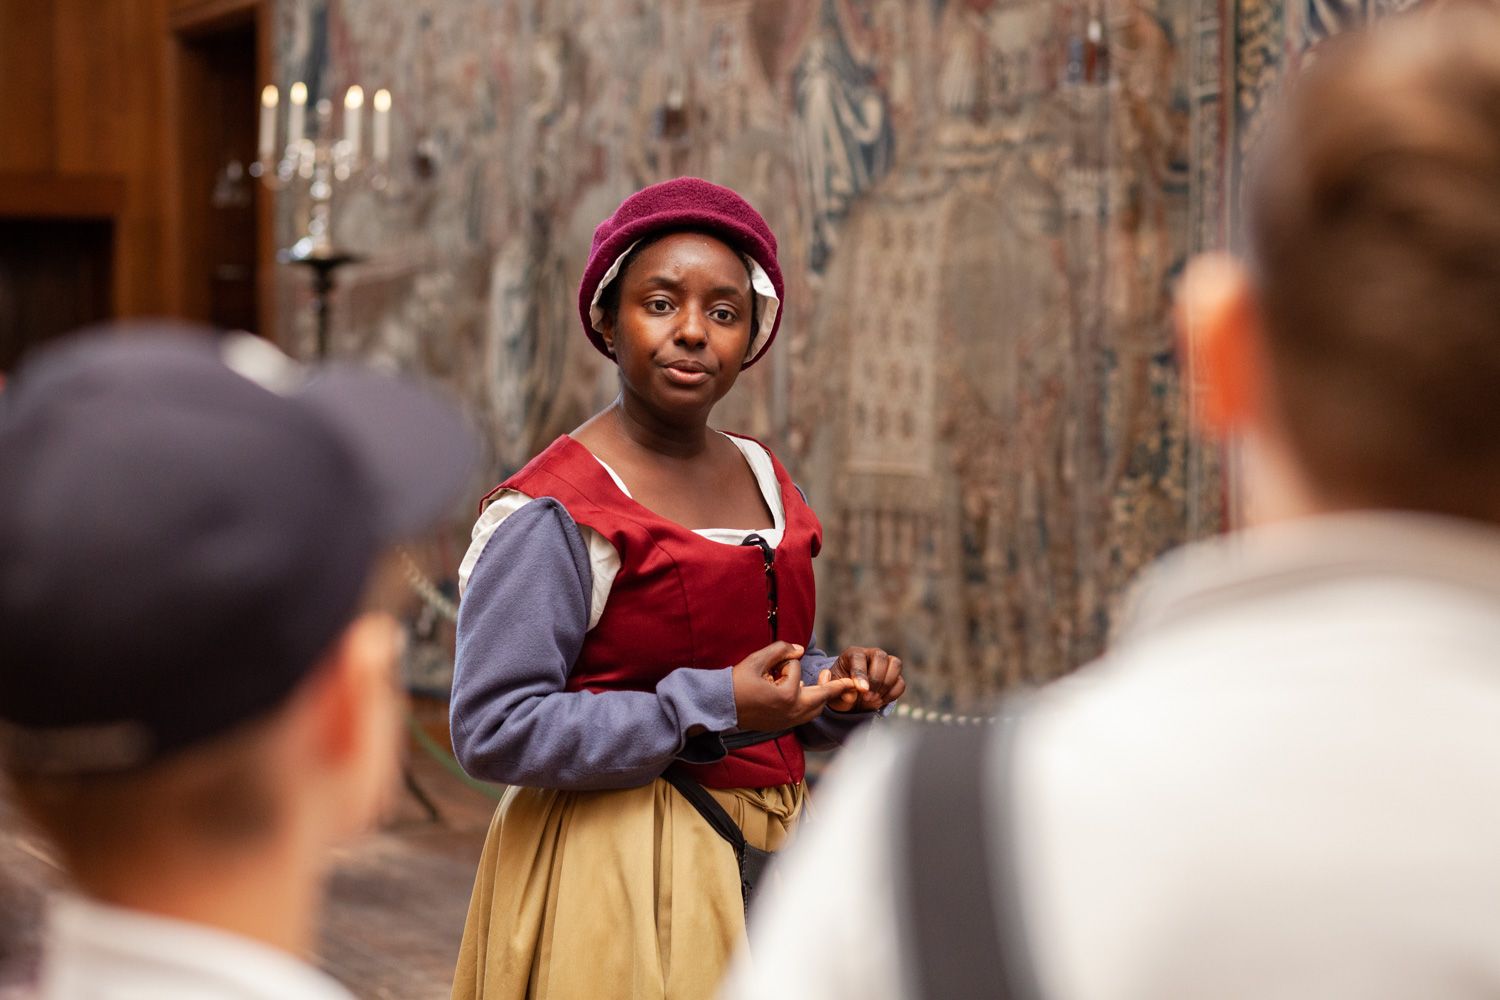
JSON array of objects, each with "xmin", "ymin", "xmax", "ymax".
[{"xmin": 1175, "ymin": 253, "xmax": 1266, "ymax": 438}]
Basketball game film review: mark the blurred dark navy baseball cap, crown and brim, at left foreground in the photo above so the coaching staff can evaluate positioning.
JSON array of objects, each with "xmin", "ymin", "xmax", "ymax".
[{"xmin": 0, "ymin": 324, "xmax": 476, "ymax": 774}]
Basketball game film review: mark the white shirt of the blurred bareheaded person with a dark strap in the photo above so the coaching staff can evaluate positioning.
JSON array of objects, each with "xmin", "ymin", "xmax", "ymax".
[{"xmin": 725, "ymin": 513, "xmax": 1500, "ymax": 1000}]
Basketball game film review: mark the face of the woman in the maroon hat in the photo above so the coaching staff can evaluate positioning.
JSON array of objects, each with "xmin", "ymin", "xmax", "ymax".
[{"xmin": 603, "ymin": 232, "xmax": 752, "ymax": 423}]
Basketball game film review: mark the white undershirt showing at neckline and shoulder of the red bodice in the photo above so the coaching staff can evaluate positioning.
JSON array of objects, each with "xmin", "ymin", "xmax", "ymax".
[{"xmin": 459, "ymin": 435, "xmax": 786, "ymax": 628}]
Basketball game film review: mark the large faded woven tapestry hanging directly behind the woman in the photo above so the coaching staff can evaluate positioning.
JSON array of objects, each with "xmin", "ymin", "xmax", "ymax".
[{"xmin": 278, "ymin": 0, "xmax": 1223, "ymax": 711}]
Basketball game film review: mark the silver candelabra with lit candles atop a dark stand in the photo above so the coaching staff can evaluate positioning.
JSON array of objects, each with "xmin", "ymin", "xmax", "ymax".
[{"xmin": 251, "ymin": 82, "xmax": 390, "ymax": 357}]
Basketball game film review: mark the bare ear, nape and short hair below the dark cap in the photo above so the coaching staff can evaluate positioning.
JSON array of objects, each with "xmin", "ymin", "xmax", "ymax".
[{"xmin": 3, "ymin": 562, "xmax": 404, "ymax": 904}]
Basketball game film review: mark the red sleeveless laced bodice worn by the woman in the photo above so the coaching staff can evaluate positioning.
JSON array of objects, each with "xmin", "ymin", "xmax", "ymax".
[{"xmin": 486, "ymin": 435, "xmax": 822, "ymax": 789}]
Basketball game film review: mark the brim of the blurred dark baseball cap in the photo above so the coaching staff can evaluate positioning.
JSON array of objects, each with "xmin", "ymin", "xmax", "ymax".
[{"xmin": 297, "ymin": 367, "xmax": 479, "ymax": 541}]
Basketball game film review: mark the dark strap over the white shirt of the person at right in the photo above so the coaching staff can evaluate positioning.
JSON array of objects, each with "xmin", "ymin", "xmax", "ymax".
[{"xmin": 899, "ymin": 714, "xmax": 1040, "ymax": 1000}]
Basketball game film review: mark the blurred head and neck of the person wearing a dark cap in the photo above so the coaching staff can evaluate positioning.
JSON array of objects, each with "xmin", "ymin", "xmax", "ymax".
[{"xmin": 0, "ymin": 325, "xmax": 474, "ymax": 951}]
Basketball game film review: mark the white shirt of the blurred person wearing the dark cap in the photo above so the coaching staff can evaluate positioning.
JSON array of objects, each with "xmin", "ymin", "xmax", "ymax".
[{"xmin": 38, "ymin": 898, "xmax": 354, "ymax": 1000}]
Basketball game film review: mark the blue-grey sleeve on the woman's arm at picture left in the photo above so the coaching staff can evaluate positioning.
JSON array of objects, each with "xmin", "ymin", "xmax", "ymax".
[{"xmin": 450, "ymin": 498, "xmax": 735, "ymax": 789}]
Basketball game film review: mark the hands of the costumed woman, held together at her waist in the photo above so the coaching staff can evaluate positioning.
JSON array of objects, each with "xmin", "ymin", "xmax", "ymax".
[{"xmin": 734, "ymin": 642, "xmax": 906, "ymax": 733}]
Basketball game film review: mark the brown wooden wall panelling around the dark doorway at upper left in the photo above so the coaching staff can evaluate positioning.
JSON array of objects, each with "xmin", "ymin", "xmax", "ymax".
[{"xmin": 0, "ymin": 0, "xmax": 275, "ymax": 327}]
